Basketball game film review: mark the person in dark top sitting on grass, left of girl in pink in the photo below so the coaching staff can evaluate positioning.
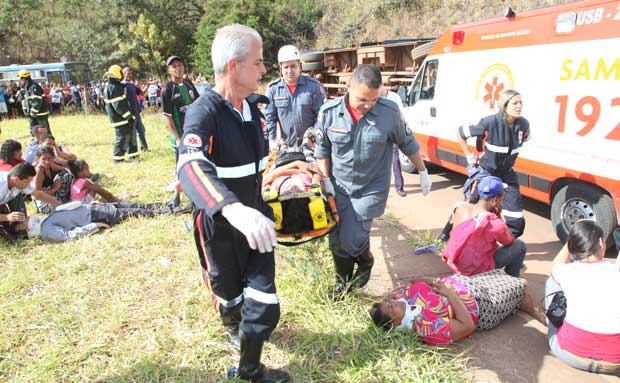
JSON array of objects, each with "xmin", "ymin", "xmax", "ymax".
[{"xmin": 34, "ymin": 146, "xmax": 73, "ymax": 214}]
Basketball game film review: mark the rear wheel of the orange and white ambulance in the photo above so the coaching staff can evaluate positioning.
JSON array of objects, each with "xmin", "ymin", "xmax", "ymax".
[{"xmin": 551, "ymin": 183, "xmax": 616, "ymax": 243}]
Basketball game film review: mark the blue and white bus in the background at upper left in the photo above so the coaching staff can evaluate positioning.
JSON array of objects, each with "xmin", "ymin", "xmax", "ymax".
[{"xmin": 0, "ymin": 61, "xmax": 91, "ymax": 85}]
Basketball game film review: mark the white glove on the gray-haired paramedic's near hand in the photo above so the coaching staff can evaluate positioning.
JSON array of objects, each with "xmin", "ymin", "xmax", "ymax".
[{"xmin": 222, "ymin": 202, "xmax": 277, "ymax": 253}]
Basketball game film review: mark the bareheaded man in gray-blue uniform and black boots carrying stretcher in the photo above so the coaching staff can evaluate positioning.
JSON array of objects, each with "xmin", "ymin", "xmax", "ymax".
[{"xmin": 314, "ymin": 64, "xmax": 431, "ymax": 298}]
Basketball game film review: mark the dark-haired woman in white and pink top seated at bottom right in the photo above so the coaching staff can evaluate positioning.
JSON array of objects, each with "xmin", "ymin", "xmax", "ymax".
[{"xmin": 545, "ymin": 220, "xmax": 620, "ymax": 375}]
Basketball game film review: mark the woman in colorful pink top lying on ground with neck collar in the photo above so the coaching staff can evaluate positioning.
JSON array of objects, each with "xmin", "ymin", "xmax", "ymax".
[{"xmin": 370, "ymin": 270, "xmax": 545, "ymax": 346}]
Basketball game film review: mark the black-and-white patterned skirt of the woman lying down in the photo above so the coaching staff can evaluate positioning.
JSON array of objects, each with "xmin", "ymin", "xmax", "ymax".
[{"xmin": 452, "ymin": 270, "xmax": 527, "ymax": 330}]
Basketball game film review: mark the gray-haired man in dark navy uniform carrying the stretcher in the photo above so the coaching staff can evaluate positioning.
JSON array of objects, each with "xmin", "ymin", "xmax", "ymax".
[{"xmin": 177, "ymin": 24, "xmax": 289, "ymax": 382}]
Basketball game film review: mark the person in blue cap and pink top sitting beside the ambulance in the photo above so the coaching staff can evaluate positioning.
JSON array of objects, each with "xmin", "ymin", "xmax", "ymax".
[{"xmin": 443, "ymin": 176, "xmax": 527, "ymax": 277}]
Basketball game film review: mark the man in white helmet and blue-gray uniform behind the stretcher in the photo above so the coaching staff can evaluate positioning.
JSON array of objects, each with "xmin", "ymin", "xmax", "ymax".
[{"xmin": 265, "ymin": 45, "xmax": 325, "ymax": 147}]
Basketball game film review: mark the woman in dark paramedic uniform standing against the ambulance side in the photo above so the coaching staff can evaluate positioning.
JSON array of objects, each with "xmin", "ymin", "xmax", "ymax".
[{"xmin": 457, "ymin": 89, "xmax": 531, "ymax": 238}]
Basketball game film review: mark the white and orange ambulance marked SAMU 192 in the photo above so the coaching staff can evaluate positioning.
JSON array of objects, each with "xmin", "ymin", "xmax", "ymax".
[{"xmin": 405, "ymin": 0, "xmax": 620, "ymax": 240}]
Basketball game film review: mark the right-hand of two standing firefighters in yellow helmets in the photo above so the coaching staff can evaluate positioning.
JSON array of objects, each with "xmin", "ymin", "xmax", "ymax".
[{"xmin": 103, "ymin": 65, "xmax": 140, "ymax": 162}]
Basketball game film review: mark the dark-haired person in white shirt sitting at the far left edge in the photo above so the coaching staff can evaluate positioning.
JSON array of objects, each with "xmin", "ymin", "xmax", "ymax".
[{"xmin": 0, "ymin": 162, "xmax": 60, "ymax": 243}]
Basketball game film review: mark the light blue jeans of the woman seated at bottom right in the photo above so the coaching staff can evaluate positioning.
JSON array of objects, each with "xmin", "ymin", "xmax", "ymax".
[{"xmin": 545, "ymin": 277, "xmax": 620, "ymax": 375}]
